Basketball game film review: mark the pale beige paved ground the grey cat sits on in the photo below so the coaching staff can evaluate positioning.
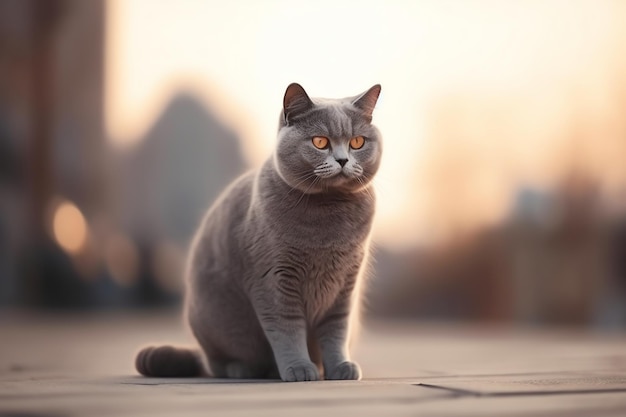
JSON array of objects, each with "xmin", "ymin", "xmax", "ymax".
[{"xmin": 0, "ymin": 312, "xmax": 626, "ymax": 417}]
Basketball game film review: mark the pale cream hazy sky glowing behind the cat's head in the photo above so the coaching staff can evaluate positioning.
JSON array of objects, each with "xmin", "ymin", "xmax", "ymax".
[{"xmin": 106, "ymin": 0, "xmax": 625, "ymax": 246}]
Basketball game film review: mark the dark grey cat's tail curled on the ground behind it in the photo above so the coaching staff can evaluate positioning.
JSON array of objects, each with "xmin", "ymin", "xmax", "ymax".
[{"xmin": 135, "ymin": 345, "xmax": 206, "ymax": 377}]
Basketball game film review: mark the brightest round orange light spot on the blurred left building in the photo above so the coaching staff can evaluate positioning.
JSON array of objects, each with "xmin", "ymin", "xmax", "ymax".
[{"xmin": 52, "ymin": 201, "xmax": 88, "ymax": 255}]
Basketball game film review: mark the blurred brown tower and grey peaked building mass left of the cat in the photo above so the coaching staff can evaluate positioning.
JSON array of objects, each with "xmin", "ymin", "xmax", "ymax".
[{"xmin": 0, "ymin": 0, "xmax": 245, "ymax": 307}]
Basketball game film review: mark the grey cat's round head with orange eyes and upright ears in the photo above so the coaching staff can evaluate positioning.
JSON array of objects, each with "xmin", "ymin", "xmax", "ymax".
[{"xmin": 274, "ymin": 83, "xmax": 382, "ymax": 193}]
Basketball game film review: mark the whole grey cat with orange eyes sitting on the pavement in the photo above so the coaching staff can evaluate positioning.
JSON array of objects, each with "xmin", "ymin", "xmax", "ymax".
[{"xmin": 136, "ymin": 83, "xmax": 382, "ymax": 381}]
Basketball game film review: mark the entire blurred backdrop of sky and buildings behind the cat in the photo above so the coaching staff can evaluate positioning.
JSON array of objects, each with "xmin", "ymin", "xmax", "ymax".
[{"xmin": 0, "ymin": 0, "xmax": 626, "ymax": 331}]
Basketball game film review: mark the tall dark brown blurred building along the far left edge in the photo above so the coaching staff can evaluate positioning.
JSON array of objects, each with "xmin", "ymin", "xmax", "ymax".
[{"xmin": 0, "ymin": 0, "xmax": 109, "ymax": 306}]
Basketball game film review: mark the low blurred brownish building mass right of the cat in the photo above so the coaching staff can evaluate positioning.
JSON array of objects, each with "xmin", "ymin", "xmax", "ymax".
[{"xmin": 369, "ymin": 167, "xmax": 626, "ymax": 329}]
